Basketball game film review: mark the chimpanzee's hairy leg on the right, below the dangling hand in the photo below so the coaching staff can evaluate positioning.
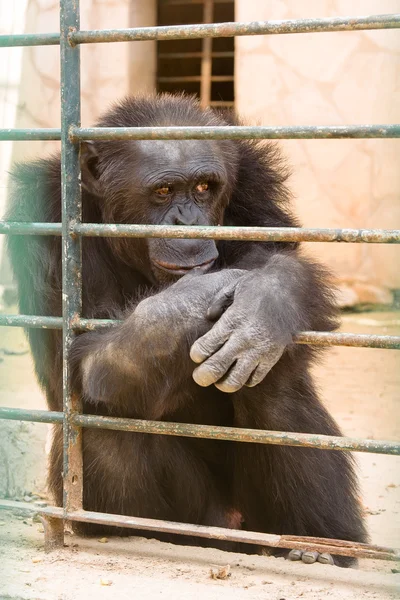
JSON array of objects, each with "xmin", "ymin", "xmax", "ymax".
[{"xmin": 234, "ymin": 366, "xmax": 367, "ymax": 566}]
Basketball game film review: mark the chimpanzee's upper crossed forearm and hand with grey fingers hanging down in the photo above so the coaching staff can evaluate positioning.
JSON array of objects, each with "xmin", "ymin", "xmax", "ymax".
[{"xmin": 190, "ymin": 244, "xmax": 337, "ymax": 392}]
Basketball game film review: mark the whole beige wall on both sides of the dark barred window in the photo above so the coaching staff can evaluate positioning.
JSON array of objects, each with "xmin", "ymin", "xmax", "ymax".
[{"xmin": 2, "ymin": 0, "xmax": 400, "ymax": 304}]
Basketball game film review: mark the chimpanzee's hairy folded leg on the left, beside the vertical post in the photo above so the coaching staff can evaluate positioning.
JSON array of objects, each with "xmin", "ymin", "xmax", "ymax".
[{"xmin": 50, "ymin": 428, "xmax": 236, "ymax": 550}]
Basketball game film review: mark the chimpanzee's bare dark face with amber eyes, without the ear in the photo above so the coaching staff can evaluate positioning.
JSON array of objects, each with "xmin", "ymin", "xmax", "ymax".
[{"xmin": 134, "ymin": 140, "xmax": 227, "ymax": 279}]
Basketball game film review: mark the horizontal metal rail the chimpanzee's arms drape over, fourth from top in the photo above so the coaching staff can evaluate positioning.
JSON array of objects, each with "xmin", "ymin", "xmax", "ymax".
[{"xmin": 0, "ymin": 315, "xmax": 400, "ymax": 350}]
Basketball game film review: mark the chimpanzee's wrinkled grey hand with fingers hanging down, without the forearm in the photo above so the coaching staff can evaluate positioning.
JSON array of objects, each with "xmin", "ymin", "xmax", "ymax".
[{"xmin": 190, "ymin": 269, "xmax": 291, "ymax": 392}]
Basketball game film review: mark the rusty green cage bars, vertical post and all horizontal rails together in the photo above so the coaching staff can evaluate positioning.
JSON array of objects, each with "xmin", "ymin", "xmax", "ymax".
[{"xmin": 0, "ymin": 0, "xmax": 400, "ymax": 560}]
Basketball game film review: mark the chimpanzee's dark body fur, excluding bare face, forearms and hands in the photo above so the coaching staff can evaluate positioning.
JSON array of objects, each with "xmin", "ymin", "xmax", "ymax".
[{"xmin": 7, "ymin": 96, "xmax": 366, "ymax": 564}]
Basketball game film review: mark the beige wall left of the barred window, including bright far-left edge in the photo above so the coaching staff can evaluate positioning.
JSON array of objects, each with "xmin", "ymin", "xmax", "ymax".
[{"xmin": 0, "ymin": 0, "xmax": 156, "ymax": 286}]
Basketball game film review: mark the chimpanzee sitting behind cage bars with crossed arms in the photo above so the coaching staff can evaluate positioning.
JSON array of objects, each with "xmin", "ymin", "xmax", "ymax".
[{"xmin": 7, "ymin": 95, "xmax": 367, "ymax": 565}]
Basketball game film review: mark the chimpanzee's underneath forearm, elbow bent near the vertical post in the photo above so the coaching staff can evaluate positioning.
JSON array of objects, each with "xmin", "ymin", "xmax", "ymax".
[{"xmin": 71, "ymin": 270, "xmax": 244, "ymax": 418}]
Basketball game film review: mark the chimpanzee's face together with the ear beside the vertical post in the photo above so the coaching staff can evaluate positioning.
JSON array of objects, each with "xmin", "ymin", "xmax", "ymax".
[{"xmin": 83, "ymin": 140, "xmax": 235, "ymax": 282}]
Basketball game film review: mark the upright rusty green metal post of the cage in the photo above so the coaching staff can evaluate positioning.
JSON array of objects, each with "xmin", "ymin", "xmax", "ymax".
[{"xmin": 60, "ymin": 0, "xmax": 83, "ymax": 524}]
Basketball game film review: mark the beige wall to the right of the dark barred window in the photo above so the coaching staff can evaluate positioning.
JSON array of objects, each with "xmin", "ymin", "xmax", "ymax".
[{"xmin": 235, "ymin": 0, "xmax": 400, "ymax": 303}]
